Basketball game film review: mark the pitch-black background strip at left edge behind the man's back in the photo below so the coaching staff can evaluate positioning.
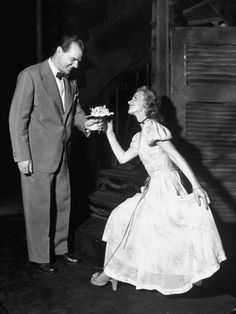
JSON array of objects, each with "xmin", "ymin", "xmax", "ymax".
[{"xmin": 3, "ymin": 0, "xmax": 36, "ymax": 200}]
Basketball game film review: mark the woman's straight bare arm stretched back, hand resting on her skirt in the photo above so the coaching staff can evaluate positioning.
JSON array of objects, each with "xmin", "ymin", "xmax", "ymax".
[{"xmin": 159, "ymin": 141, "xmax": 209, "ymax": 208}]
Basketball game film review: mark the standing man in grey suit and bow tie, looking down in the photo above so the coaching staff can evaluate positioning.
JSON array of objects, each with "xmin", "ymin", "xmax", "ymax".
[{"xmin": 9, "ymin": 36, "xmax": 101, "ymax": 274}]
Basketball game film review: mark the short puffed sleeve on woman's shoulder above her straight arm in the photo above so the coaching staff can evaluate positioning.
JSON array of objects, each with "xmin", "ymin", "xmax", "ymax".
[{"xmin": 143, "ymin": 120, "xmax": 172, "ymax": 146}]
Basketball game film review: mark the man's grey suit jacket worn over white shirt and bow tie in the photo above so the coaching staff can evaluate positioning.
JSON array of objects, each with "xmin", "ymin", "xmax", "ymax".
[{"xmin": 9, "ymin": 60, "xmax": 86, "ymax": 173}]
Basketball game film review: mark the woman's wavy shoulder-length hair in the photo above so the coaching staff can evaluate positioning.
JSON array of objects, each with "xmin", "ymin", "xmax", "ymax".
[{"xmin": 137, "ymin": 85, "xmax": 163, "ymax": 122}]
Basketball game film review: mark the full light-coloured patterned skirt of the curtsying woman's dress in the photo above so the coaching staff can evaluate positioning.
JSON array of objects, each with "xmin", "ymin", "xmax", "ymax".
[{"xmin": 103, "ymin": 171, "xmax": 226, "ymax": 295}]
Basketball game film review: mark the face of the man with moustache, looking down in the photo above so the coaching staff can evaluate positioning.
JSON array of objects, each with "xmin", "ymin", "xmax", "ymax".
[{"xmin": 58, "ymin": 43, "xmax": 83, "ymax": 74}]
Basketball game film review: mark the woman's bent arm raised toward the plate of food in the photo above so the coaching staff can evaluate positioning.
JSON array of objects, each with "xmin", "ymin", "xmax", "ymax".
[{"xmin": 105, "ymin": 121, "xmax": 138, "ymax": 164}]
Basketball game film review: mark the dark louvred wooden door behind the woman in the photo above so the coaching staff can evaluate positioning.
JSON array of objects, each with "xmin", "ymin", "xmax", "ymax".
[{"xmin": 170, "ymin": 27, "xmax": 236, "ymax": 223}]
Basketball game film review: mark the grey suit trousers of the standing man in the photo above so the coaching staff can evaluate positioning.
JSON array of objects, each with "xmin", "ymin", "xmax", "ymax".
[{"xmin": 21, "ymin": 153, "xmax": 71, "ymax": 263}]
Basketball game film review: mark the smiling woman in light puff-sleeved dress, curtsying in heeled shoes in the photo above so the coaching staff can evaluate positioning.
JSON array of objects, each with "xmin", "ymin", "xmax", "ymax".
[{"xmin": 91, "ymin": 86, "xmax": 226, "ymax": 295}]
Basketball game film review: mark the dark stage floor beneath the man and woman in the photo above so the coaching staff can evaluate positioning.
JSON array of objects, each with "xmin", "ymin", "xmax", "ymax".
[{"xmin": 0, "ymin": 198, "xmax": 236, "ymax": 314}]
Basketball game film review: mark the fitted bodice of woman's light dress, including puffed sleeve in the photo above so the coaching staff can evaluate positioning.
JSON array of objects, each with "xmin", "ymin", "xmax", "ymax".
[{"xmin": 130, "ymin": 119, "xmax": 174, "ymax": 176}]
